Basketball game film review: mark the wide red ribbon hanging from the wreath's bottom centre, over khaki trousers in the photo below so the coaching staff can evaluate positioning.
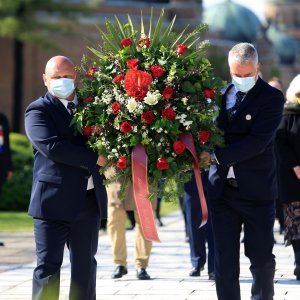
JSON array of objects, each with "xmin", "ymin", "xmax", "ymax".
[{"xmin": 131, "ymin": 144, "xmax": 160, "ymax": 242}]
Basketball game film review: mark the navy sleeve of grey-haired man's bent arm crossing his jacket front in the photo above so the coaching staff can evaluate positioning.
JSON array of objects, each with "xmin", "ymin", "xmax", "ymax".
[{"xmin": 215, "ymin": 96, "xmax": 284, "ymax": 166}]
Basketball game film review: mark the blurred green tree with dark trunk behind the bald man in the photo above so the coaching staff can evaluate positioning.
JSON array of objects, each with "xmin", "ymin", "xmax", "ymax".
[{"xmin": 0, "ymin": 0, "xmax": 97, "ymax": 132}]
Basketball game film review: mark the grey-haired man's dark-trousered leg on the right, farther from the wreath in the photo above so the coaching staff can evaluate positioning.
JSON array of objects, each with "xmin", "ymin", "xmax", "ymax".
[{"xmin": 241, "ymin": 201, "xmax": 275, "ymax": 300}]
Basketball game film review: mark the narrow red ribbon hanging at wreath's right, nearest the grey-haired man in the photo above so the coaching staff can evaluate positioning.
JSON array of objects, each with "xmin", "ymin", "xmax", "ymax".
[{"xmin": 179, "ymin": 133, "xmax": 208, "ymax": 227}]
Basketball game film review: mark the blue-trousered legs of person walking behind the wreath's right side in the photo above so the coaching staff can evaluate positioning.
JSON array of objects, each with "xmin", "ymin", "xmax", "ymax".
[{"xmin": 183, "ymin": 170, "xmax": 215, "ymax": 280}]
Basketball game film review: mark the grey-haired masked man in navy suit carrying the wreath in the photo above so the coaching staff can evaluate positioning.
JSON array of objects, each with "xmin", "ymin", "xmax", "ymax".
[{"xmin": 201, "ymin": 43, "xmax": 284, "ymax": 300}]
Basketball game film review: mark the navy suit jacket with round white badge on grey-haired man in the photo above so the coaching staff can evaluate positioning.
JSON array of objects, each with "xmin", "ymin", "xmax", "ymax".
[{"xmin": 208, "ymin": 78, "xmax": 284, "ymax": 200}]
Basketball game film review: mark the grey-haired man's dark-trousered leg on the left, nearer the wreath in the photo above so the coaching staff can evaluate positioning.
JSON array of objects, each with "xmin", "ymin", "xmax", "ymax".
[{"xmin": 211, "ymin": 187, "xmax": 242, "ymax": 300}]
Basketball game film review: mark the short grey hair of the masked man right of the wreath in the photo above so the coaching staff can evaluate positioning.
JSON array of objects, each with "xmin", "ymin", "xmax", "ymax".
[{"xmin": 228, "ymin": 43, "xmax": 258, "ymax": 65}]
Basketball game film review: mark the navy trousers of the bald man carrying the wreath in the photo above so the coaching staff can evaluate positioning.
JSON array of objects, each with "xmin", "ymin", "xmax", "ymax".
[{"xmin": 32, "ymin": 194, "xmax": 100, "ymax": 300}]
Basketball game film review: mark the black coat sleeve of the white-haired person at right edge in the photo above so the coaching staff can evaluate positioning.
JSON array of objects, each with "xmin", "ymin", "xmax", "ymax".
[{"xmin": 276, "ymin": 116, "xmax": 299, "ymax": 169}]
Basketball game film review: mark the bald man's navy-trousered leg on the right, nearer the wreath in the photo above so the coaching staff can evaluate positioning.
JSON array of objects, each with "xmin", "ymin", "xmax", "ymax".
[{"xmin": 68, "ymin": 195, "xmax": 100, "ymax": 300}]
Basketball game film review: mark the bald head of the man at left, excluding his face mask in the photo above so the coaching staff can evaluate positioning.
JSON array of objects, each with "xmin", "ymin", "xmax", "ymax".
[{"xmin": 43, "ymin": 55, "xmax": 76, "ymax": 100}]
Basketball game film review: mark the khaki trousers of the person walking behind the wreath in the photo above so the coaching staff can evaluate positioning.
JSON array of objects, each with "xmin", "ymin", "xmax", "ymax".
[{"xmin": 107, "ymin": 206, "xmax": 152, "ymax": 269}]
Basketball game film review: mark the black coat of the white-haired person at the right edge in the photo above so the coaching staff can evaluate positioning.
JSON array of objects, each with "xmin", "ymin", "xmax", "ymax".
[{"xmin": 276, "ymin": 104, "xmax": 300, "ymax": 203}]
